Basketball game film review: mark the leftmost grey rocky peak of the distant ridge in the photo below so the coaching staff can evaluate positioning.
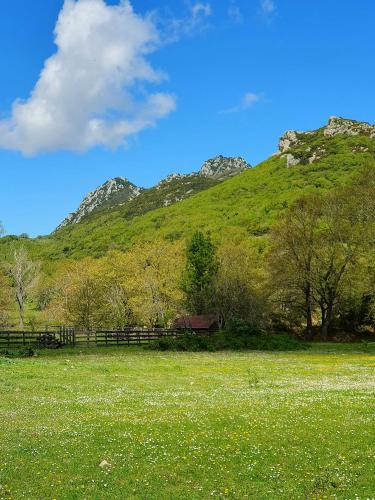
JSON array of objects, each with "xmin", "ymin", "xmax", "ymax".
[{"xmin": 57, "ymin": 177, "xmax": 142, "ymax": 230}]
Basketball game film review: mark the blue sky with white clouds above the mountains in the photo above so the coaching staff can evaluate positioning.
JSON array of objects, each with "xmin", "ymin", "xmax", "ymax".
[{"xmin": 0, "ymin": 0, "xmax": 375, "ymax": 236}]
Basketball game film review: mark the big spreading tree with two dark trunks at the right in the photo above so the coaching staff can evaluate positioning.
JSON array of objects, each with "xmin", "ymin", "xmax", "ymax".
[{"xmin": 270, "ymin": 169, "xmax": 375, "ymax": 338}]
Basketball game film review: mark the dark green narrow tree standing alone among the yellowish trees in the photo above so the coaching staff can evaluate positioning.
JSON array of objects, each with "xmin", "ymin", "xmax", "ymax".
[{"xmin": 182, "ymin": 231, "xmax": 219, "ymax": 314}]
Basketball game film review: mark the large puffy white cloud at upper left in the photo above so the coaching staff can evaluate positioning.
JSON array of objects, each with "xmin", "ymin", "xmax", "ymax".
[{"xmin": 0, "ymin": 0, "xmax": 178, "ymax": 155}]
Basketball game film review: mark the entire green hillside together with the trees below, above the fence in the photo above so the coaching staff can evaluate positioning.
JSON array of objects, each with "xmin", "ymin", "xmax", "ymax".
[{"xmin": 0, "ymin": 124, "xmax": 375, "ymax": 339}]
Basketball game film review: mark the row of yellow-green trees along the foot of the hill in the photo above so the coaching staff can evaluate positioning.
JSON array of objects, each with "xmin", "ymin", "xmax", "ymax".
[{"xmin": 0, "ymin": 167, "xmax": 375, "ymax": 339}]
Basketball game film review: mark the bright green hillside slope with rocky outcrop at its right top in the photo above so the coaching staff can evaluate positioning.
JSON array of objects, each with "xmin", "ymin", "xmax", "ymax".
[{"xmin": 1, "ymin": 120, "xmax": 375, "ymax": 259}]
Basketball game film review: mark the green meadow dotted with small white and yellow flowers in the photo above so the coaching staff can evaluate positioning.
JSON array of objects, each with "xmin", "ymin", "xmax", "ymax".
[{"xmin": 0, "ymin": 345, "xmax": 375, "ymax": 499}]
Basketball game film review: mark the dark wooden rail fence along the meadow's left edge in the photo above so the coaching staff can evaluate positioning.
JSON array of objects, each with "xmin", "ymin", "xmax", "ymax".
[{"xmin": 0, "ymin": 327, "xmax": 183, "ymax": 349}]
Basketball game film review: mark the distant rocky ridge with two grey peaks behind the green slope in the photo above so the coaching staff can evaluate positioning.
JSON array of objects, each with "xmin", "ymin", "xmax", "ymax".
[{"xmin": 56, "ymin": 156, "xmax": 251, "ymax": 231}]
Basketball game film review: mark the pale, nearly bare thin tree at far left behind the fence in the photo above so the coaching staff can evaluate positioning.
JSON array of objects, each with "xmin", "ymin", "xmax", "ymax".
[{"xmin": 7, "ymin": 248, "xmax": 39, "ymax": 328}]
